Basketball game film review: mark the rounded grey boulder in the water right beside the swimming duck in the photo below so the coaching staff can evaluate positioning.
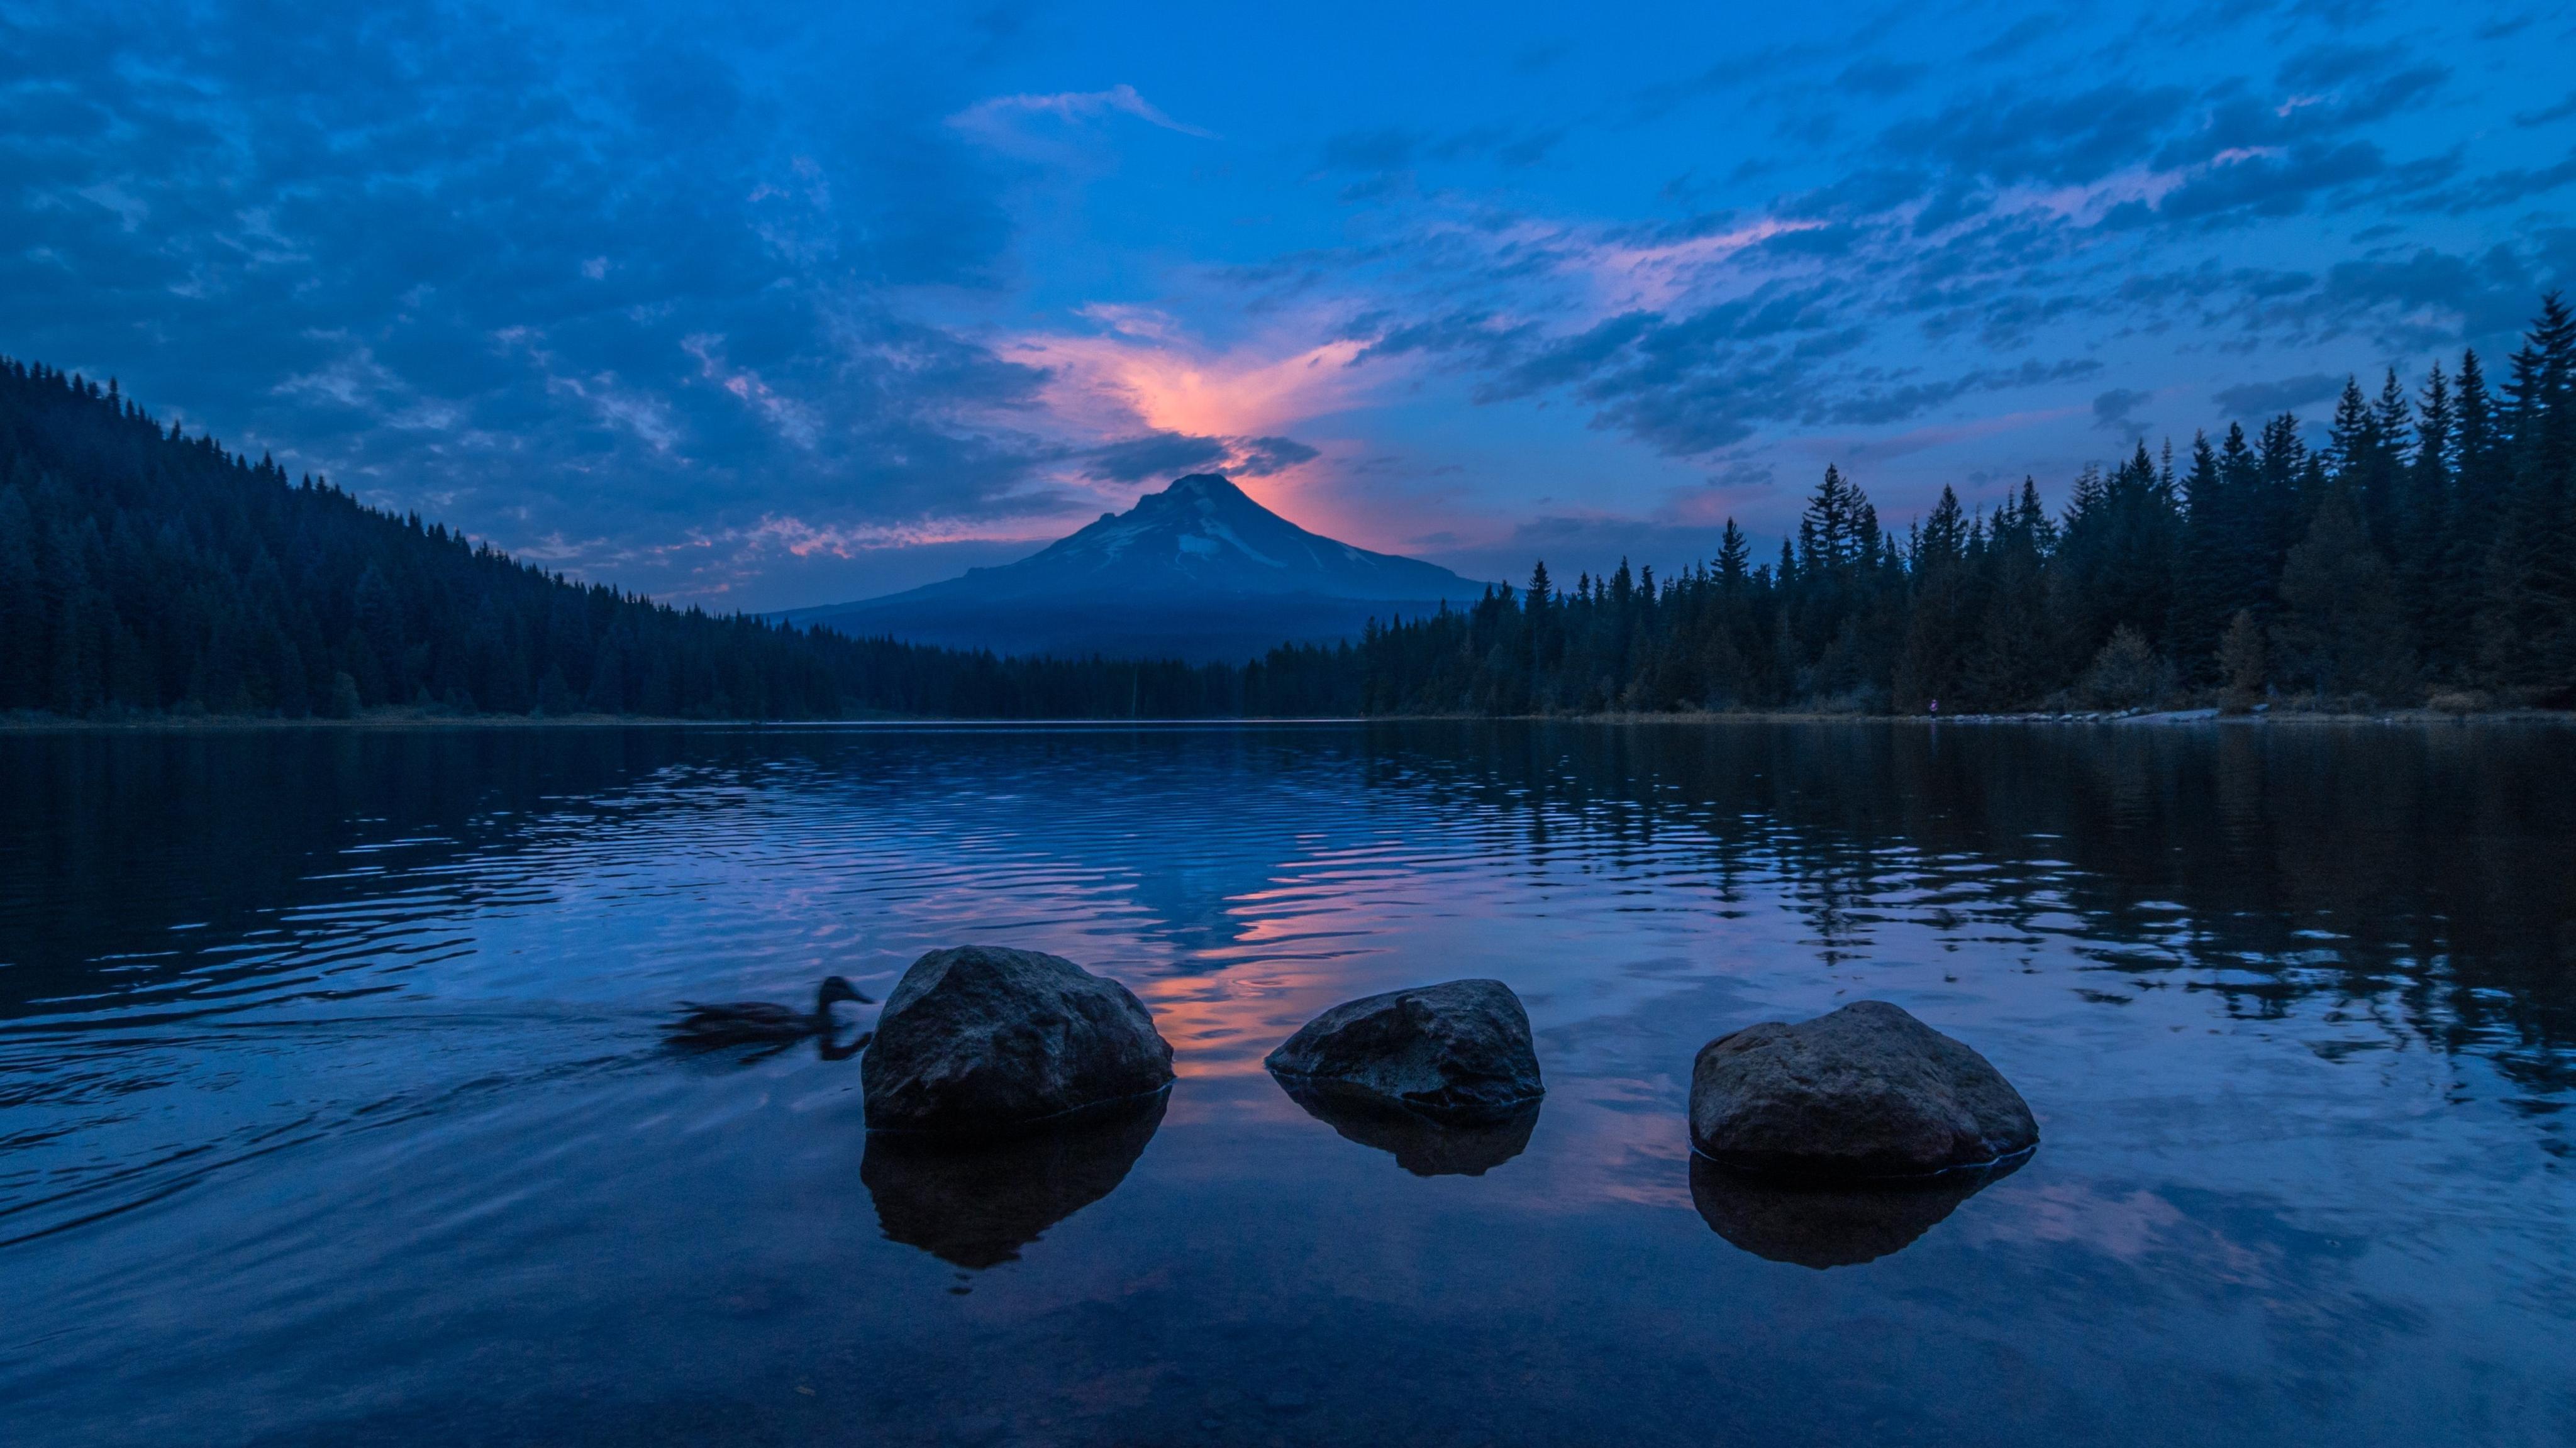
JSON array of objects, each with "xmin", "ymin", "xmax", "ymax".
[{"xmin": 858, "ymin": 946, "xmax": 1172, "ymax": 1136}]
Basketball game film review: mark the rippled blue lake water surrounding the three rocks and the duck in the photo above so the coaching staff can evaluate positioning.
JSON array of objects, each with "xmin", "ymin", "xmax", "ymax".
[{"xmin": 0, "ymin": 724, "xmax": 2576, "ymax": 1448}]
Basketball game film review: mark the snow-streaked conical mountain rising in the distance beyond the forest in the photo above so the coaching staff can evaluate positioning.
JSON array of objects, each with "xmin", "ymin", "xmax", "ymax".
[{"xmin": 780, "ymin": 472, "xmax": 1484, "ymax": 662}]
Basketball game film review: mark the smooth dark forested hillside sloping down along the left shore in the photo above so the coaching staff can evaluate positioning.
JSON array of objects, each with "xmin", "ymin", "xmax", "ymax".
[{"xmin": 0, "ymin": 361, "xmax": 1358, "ymax": 719}]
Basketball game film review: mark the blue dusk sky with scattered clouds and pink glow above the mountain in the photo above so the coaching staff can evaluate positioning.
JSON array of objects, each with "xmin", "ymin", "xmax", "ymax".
[{"xmin": 0, "ymin": 0, "xmax": 2576, "ymax": 600}]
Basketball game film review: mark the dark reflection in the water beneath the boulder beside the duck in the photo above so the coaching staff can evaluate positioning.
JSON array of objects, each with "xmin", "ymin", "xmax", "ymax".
[{"xmin": 858, "ymin": 1092, "xmax": 1170, "ymax": 1270}]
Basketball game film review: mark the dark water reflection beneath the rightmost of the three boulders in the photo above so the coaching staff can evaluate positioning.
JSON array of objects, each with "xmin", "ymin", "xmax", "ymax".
[{"xmin": 1690, "ymin": 1152, "xmax": 2030, "ymax": 1270}]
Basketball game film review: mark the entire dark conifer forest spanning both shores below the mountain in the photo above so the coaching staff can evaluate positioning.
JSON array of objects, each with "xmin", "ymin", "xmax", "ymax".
[{"xmin": 0, "ymin": 294, "xmax": 2576, "ymax": 719}]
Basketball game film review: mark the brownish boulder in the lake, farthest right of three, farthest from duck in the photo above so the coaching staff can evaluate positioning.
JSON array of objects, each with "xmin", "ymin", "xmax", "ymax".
[{"xmin": 1690, "ymin": 1000, "xmax": 2040, "ymax": 1180}]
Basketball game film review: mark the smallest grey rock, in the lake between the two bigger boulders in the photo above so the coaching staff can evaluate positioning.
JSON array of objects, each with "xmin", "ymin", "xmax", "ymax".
[{"xmin": 1262, "ymin": 981, "xmax": 1548, "ymax": 1121}]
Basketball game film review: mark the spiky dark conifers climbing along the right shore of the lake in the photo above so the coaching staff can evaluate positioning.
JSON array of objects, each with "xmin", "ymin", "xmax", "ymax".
[{"xmin": 1360, "ymin": 294, "xmax": 2576, "ymax": 714}]
